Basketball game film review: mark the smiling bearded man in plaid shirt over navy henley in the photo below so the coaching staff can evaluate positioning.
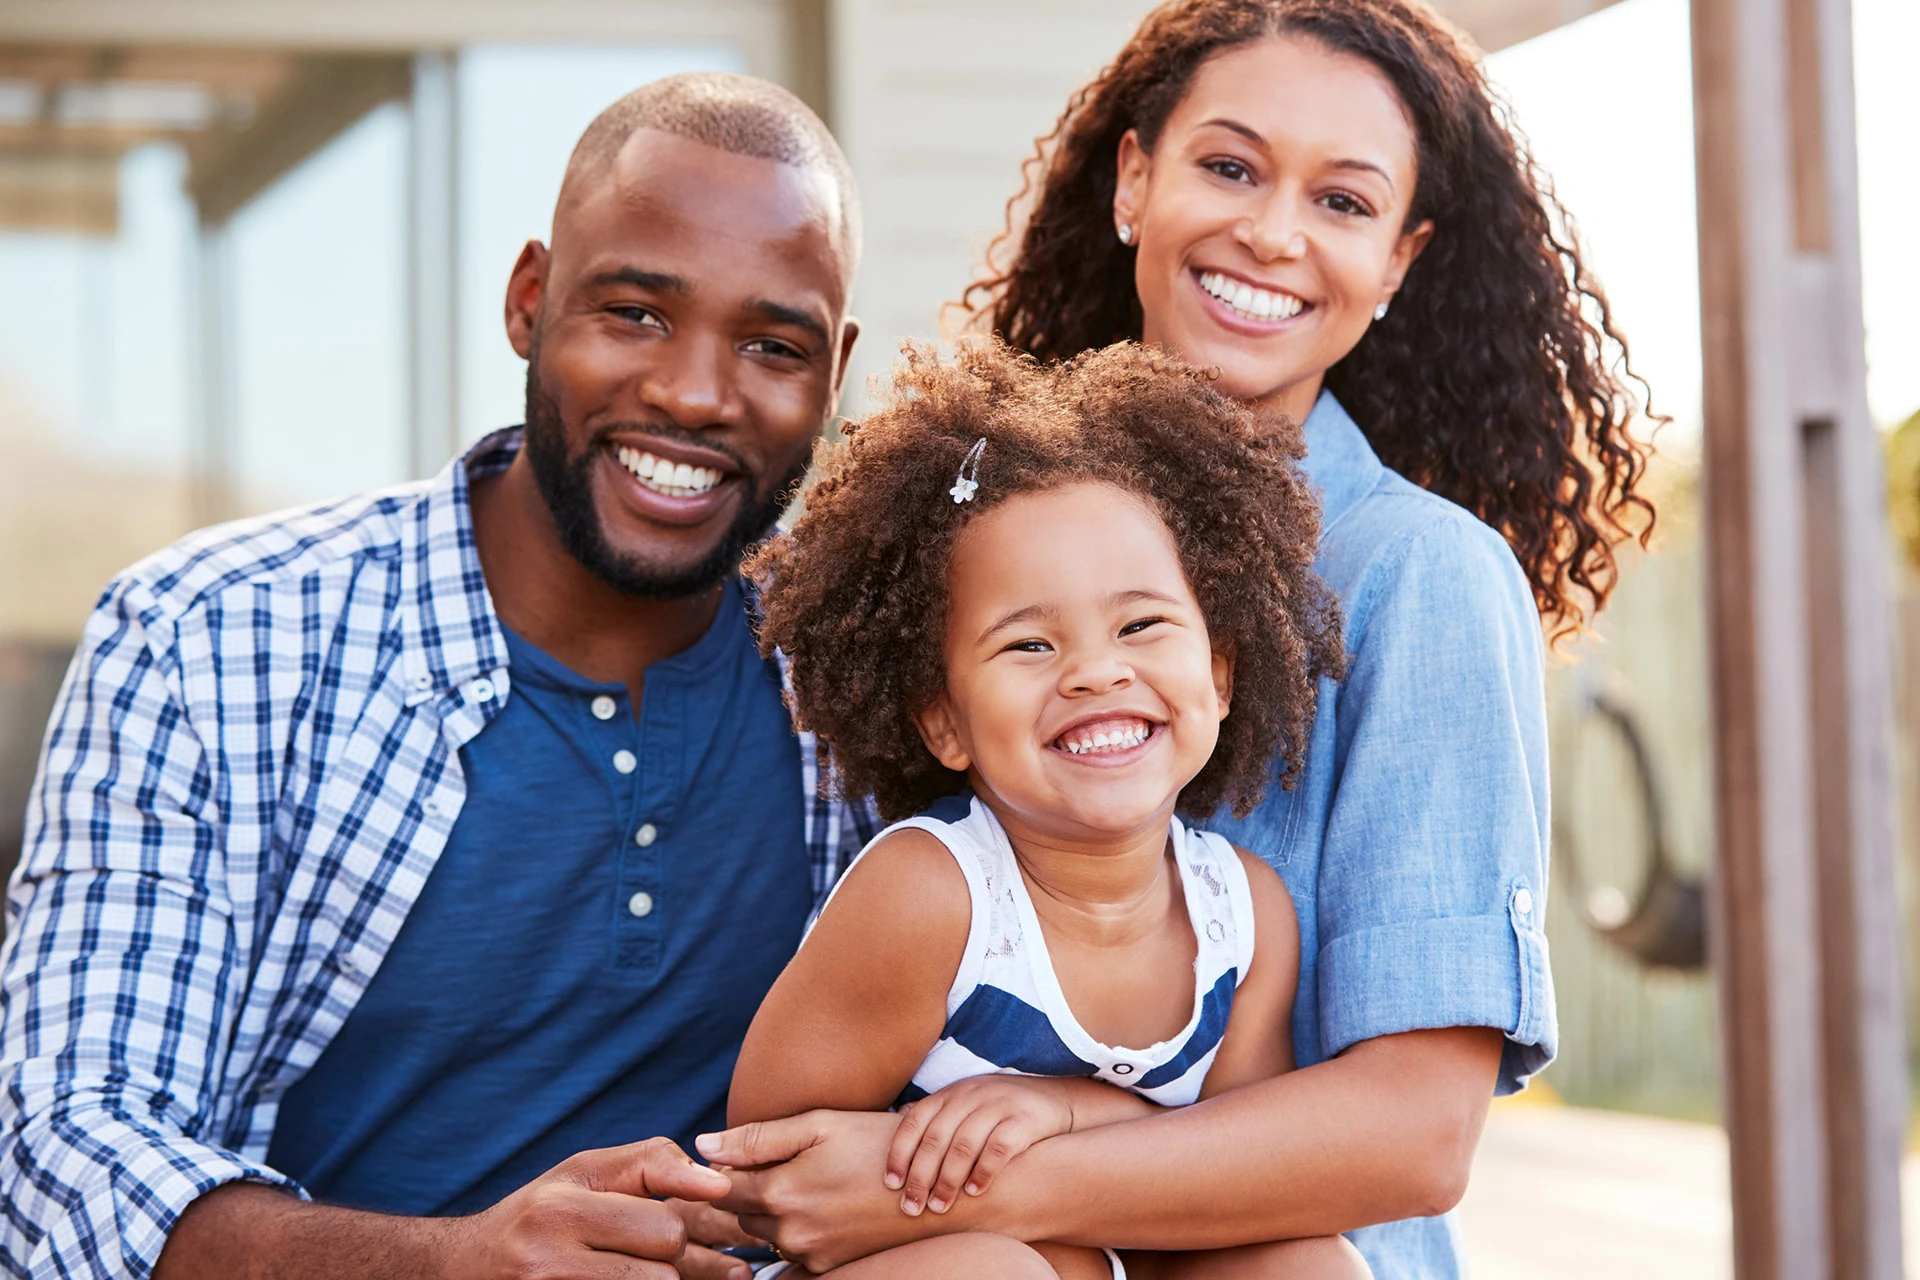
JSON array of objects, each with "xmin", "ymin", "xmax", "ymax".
[{"xmin": 0, "ymin": 75, "xmax": 866, "ymax": 1280}]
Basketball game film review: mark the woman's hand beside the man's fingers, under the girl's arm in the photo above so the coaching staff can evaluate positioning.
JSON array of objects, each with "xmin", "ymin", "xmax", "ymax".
[{"xmin": 699, "ymin": 1111, "xmax": 985, "ymax": 1272}]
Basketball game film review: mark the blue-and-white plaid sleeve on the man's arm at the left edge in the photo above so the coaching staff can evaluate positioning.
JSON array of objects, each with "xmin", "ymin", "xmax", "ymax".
[{"xmin": 0, "ymin": 585, "xmax": 298, "ymax": 1280}]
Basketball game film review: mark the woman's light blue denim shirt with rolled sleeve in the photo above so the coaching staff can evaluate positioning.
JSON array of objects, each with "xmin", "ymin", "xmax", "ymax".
[{"xmin": 1206, "ymin": 391, "xmax": 1557, "ymax": 1280}]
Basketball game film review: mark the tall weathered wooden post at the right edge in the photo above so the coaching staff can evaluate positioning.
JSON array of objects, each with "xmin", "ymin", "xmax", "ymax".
[{"xmin": 1693, "ymin": 0, "xmax": 1907, "ymax": 1280}]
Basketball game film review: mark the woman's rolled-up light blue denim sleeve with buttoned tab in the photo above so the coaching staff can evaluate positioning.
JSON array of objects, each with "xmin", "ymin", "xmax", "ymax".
[{"xmin": 1317, "ymin": 512, "xmax": 1557, "ymax": 1094}]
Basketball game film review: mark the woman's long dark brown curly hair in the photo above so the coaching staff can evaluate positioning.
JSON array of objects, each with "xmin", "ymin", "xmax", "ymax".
[{"xmin": 964, "ymin": 0, "xmax": 1661, "ymax": 637}]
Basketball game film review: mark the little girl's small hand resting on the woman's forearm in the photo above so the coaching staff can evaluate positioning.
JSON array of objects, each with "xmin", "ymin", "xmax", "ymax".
[{"xmin": 885, "ymin": 1075, "xmax": 1104, "ymax": 1215}]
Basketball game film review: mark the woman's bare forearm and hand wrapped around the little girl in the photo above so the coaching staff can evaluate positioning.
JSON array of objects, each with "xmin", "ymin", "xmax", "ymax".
[{"xmin": 699, "ymin": 1027, "xmax": 1503, "ymax": 1270}]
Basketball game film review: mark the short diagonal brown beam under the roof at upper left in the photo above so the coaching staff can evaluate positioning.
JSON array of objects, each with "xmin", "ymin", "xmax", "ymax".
[{"xmin": 186, "ymin": 56, "xmax": 413, "ymax": 223}]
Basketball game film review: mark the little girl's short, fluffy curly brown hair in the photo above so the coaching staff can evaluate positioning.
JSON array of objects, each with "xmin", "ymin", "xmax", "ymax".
[{"xmin": 747, "ymin": 338, "xmax": 1346, "ymax": 819}]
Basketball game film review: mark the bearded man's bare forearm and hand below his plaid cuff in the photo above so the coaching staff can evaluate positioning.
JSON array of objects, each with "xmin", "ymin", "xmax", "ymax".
[{"xmin": 154, "ymin": 1138, "xmax": 733, "ymax": 1280}]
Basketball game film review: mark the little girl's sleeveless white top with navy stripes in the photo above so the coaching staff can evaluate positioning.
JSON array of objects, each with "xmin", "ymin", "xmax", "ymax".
[{"xmin": 833, "ymin": 798, "xmax": 1254, "ymax": 1107}]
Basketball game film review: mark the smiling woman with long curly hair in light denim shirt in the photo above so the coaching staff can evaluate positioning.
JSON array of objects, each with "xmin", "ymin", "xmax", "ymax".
[{"xmin": 707, "ymin": 0, "xmax": 1651, "ymax": 1280}]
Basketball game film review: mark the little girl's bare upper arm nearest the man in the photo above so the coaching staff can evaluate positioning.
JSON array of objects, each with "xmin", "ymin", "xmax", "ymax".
[{"xmin": 728, "ymin": 827, "xmax": 973, "ymax": 1128}]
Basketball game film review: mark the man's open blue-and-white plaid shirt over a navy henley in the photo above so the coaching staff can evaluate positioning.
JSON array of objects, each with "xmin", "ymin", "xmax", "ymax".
[{"xmin": 0, "ymin": 430, "xmax": 874, "ymax": 1278}]
